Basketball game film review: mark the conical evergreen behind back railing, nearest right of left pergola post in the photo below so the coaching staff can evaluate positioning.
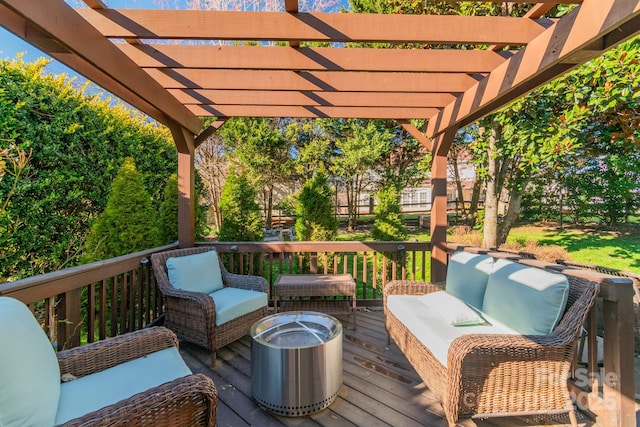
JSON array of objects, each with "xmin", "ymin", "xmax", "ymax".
[{"xmin": 219, "ymin": 169, "xmax": 264, "ymax": 242}]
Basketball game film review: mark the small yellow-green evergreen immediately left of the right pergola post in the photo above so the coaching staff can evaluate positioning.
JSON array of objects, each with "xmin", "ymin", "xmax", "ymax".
[{"xmin": 371, "ymin": 186, "xmax": 408, "ymax": 241}]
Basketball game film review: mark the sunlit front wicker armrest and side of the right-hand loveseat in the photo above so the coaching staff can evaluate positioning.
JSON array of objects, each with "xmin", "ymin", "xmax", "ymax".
[{"xmin": 446, "ymin": 334, "xmax": 574, "ymax": 417}]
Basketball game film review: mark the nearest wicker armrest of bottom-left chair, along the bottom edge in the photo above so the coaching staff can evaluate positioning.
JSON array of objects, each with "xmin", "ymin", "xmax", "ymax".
[{"xmin": 57, "ymin": 374, "xmax": 218, "ymax": 427}]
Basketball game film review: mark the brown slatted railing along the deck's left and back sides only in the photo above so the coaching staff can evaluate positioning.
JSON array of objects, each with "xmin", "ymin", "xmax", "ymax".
[{"xmin": 0, "ymin": 242, "xmax": 430, "ymax": 349}]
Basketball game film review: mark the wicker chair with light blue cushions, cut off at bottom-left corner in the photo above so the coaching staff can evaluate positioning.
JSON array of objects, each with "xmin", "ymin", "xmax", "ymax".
[{"xmin": 0, "ymin": 297, "xmax": 218, "ymax": 427}]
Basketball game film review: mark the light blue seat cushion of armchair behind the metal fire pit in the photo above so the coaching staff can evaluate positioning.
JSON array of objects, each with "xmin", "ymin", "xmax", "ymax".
[{"xmin": 209, "ymin": 287, "xmax": 268, "ymax": 326}]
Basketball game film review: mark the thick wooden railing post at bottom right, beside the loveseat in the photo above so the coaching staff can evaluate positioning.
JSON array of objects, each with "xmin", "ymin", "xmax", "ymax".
[{"xmin": 601, "ymin": 278, "xmax": 636, "ymax": 427}]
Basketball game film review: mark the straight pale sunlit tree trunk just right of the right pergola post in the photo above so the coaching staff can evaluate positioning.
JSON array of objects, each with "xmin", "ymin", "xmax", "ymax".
[{"xmin": 482, "ymin": 124, "xmax": 500, "ymax": 248}]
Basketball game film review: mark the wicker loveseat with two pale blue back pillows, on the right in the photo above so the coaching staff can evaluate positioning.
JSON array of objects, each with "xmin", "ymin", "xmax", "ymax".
[{"xmin": 383, "ymin": 252, "xmax": 599, "ymax": 426}]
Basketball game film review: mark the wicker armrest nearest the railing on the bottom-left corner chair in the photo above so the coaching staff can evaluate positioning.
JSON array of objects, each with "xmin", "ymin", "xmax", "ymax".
[{"xmin": 57, "ymin": 326, "xmax": 178, "ymax": 377}]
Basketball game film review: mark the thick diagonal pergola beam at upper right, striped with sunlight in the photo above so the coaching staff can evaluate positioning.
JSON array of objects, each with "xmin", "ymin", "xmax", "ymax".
[{"xmin": 427, "ymin": 0, "xmax": 640, "ymax": 137}]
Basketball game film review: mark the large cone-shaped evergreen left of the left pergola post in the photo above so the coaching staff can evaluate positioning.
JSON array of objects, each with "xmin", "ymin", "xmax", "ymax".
[{"xmin": 84, "ymin": 157, "xmax": 157, "ymax": 262}]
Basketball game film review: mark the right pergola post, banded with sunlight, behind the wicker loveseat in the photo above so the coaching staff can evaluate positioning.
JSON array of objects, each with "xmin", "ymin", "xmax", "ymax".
[{"xmin": 430, "ymin": 130, "xmax": 456, "ymax": 282}]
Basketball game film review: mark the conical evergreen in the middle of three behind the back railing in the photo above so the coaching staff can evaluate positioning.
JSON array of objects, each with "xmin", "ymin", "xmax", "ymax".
[{"xmin": 296, "ymin": 172, "xmax": 338, "ymax": 241}]
